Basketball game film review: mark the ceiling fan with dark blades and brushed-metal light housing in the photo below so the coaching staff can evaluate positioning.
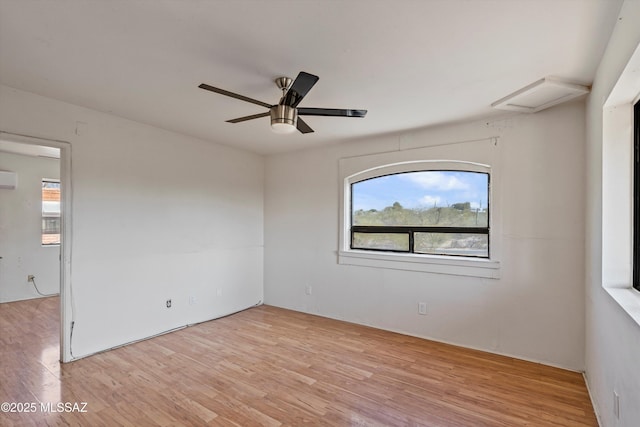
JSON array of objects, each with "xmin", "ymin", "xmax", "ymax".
[{"xmin": 198, "ymin": 71, "xmax": 367, "ymax": 133}]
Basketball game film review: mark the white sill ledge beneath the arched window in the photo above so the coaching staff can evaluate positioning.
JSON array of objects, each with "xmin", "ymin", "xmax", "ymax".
[{"xmin": 338, "ymin": 250, "xmax": 500, "ymax": 279}]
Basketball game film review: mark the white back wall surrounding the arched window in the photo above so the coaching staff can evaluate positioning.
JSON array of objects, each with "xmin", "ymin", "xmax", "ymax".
[{"xmin": 265, "ymin": 101, "xmax": 585, "ymax": 370}]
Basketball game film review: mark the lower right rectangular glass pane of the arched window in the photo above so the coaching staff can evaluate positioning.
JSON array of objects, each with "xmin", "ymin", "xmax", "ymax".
[{"xmin": 414, "ymin": 232, "xmax": 489, "ymax": 258}]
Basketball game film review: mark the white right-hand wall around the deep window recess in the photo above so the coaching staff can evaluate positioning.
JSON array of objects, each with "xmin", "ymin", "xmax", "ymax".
[{"xmin": 586, "ymin": 0, "xmax": 640, "ymax": 427}]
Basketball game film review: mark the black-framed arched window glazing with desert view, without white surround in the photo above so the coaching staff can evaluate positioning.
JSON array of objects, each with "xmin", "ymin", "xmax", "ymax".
[{"xmin": 350, "ymin": 170, "xmax": 489, "ymax": 258}]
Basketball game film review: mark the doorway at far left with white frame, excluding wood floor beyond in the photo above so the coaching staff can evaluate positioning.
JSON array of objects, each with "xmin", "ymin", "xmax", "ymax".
[{"xmin": 0, "ymin": 131, "xmax": 72, "ymax": 362}]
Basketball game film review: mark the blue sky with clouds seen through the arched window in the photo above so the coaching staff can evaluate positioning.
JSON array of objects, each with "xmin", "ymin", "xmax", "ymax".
[{"xmin": 351, "ymin": 171, "xmax": 489, "ymax": 211}]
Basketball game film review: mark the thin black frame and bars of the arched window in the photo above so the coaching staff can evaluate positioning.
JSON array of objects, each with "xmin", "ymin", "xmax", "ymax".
[{"xmin": 349, "ymin": 170, "xmax": 491, "ymax": 259}]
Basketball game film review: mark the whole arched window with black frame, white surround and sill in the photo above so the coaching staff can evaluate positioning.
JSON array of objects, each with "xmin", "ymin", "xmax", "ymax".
[{"xmin": 338, "ymin": 142, "xmax": 502, "ymax": 279}]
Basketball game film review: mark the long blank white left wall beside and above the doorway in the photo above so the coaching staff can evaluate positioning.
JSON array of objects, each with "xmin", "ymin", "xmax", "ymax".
[{"xmin": 0, "ymin": 86, "xmax": 263, "ymax": 357}]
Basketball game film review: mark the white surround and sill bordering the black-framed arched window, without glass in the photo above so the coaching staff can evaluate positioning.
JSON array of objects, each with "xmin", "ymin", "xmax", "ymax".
[{"xmin": 337, "ymin": 155, "xmax": 501, "ymax": 279}]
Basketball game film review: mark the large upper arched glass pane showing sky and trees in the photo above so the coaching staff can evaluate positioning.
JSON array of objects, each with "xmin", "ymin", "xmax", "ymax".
[{"xmin": 351, "ymin": 171, "xmax": 489, "ymax": 227}]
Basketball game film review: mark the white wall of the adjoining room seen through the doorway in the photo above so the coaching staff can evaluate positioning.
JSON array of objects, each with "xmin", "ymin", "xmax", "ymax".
[{"xmin": 0, "ymin": 152, "xmax": 60, "ymax": 303}]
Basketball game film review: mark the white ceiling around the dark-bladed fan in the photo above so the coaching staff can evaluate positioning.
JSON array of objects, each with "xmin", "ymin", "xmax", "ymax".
[{"xmin": 0, "ymin": 0, "xmax": 622, "ymax": 154}]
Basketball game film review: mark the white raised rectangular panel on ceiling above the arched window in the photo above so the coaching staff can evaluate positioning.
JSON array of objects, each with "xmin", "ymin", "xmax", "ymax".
[{"xmin": 491, "ymin": 77, "xmax": 589, "ymax": 113}]
